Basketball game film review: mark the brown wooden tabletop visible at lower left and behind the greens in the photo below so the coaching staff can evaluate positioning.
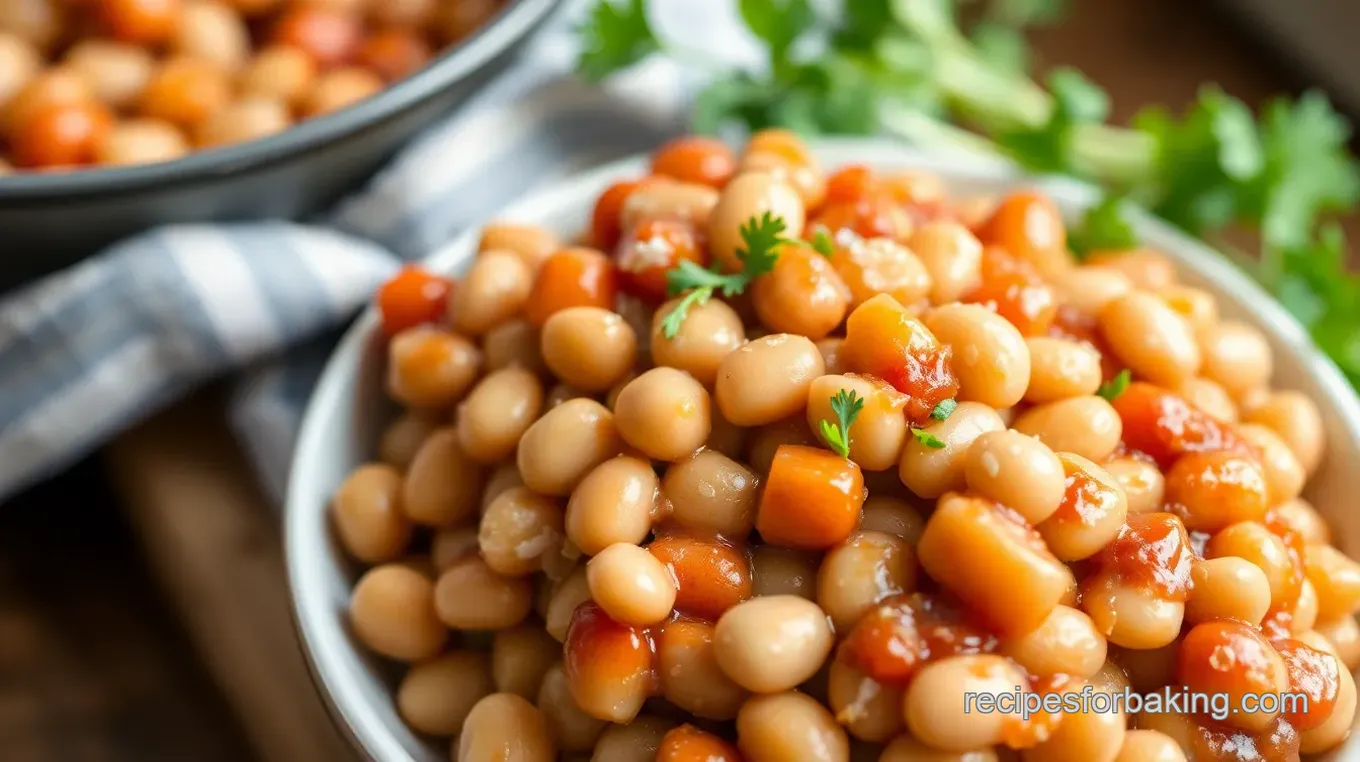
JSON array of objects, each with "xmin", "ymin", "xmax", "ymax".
[{"xmin": 0, "ymin": 0, "xmax": 1343, "ymax": 762}]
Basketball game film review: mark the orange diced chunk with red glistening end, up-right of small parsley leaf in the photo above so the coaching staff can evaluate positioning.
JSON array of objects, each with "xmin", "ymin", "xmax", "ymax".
[{"xmin": 840, "ymin": 294, "xmax": 959, "ymax": 426}]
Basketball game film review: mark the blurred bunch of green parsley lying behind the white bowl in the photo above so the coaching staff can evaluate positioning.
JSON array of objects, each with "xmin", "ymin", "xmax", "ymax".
[{"xmin": 579, "ymin": 0, "xmax": 1360, "ymax": 384}]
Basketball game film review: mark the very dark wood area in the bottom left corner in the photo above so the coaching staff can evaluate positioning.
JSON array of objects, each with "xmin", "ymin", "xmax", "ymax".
[{"xmin": 0, "ymin": 454, "xmax": 252, "ymax": 762}]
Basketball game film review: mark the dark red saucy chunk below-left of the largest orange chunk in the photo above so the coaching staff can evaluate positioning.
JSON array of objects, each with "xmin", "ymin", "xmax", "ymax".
[{"xmin": 843, "ymin": 593, "xmax": 997, "ymax": 684}]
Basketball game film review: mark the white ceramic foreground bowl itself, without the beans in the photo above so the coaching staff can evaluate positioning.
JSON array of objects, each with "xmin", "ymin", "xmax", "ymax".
[{"xmin": 286, "ymin": 140, "xmax": 1360, "ymax": 762}]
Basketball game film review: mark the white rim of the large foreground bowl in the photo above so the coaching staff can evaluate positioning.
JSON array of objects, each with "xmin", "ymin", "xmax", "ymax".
[{"xmin": 283, "ymin": 139, "xmax": 1360, "ymax": 762}]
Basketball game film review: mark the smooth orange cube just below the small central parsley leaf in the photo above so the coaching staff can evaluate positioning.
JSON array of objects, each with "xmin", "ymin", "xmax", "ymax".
[{"xmin": 756, "ymin": 445, "xmax": 864, "ymax": 550}]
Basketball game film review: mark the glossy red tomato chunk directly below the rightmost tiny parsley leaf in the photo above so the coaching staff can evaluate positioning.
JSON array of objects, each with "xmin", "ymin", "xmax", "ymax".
[{"xmin": 1114, "ymin": 381, "xmax": 1250, "ymax": 471}]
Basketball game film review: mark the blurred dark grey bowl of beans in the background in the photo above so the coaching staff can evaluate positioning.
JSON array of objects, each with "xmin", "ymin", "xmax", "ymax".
[{"xmin": 0, "ymin": 0, "xmax": 558, "ymax": 288}]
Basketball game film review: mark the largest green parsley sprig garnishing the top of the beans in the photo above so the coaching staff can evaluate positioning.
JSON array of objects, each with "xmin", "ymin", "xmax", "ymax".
[{"xmin": 661, "ymin": 212, "xmax": 830, "ymax": 339}]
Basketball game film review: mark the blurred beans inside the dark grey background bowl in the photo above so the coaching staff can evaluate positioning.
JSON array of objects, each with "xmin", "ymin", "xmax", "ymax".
[{"xmin": 0, "ymin": 0, "xmax": 503, "ymax": 173}]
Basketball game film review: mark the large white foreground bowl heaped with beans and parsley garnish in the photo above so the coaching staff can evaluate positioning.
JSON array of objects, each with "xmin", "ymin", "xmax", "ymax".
[{"xmin": 286, "ymin": 131, "xmax": 1360, "ymax": 762}]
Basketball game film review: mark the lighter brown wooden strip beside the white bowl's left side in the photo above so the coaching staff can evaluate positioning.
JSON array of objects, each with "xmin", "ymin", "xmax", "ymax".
[{"xmin": 107, "ymin": 393, "xmax": 354, "ymax": 762}]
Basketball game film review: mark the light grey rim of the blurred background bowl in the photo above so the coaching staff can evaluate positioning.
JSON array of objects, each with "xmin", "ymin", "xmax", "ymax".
[{"xmin": 0, "ymin": 0, "xmax": 563, "ymax": 203}]
